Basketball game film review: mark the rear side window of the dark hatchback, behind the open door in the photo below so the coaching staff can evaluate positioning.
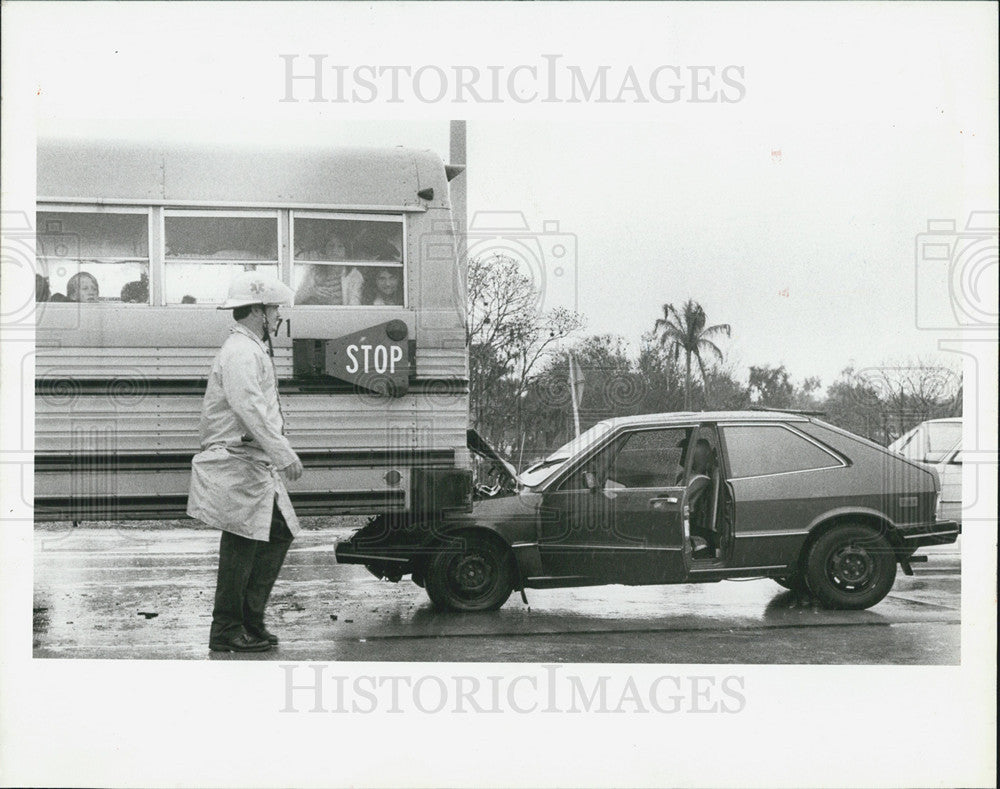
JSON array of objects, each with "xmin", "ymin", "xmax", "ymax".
[{"xmin": 723, "ymin": 425, "xmax": 843, "ymax": 478}]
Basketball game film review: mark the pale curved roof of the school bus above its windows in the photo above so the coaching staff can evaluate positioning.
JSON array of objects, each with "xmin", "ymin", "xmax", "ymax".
[{"xmin": 37, "ymin": 140, "xmax": 449, "ymax": 211}]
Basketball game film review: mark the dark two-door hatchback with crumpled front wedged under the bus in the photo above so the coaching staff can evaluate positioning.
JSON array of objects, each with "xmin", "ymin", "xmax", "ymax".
[{"xmin": 337, "ymin": 411, "xmax": 959, "ymax": 611}]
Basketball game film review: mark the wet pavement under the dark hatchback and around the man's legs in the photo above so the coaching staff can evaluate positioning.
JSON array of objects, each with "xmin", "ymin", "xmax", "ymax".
[{"xmin": 33, "ymin": 527, "xmax": 961, "ymax": 665}]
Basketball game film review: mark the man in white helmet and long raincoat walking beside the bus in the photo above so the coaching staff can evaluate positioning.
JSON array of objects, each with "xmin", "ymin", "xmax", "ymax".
[{"xmin": 187, "ymin": 271, "xmax": 302, "ymax": 652}]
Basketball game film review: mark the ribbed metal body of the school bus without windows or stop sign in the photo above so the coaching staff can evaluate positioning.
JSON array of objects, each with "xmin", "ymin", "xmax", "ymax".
[{"xmin": 34, "ymin": 142, "xmax": 471, "ymax": 520}]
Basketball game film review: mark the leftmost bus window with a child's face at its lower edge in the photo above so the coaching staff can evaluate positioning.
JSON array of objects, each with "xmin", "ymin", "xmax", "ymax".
[{"xmin": 35, "ymin": 210, "xmax": 149, "ymax": 304}]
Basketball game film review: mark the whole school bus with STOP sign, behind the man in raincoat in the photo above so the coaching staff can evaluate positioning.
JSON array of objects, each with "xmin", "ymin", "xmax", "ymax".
[{"xmin": 34, "ymin": 140, "xmax": 472, "ymax": 521}]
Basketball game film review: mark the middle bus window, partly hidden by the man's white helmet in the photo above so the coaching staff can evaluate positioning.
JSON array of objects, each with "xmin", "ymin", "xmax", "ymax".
[{"xmin": 163, "ymin": 211, "xmax": 278, "ymax": 304}]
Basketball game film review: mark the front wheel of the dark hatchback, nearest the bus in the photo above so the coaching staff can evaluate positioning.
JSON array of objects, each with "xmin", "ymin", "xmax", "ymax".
[{"xmin": 425, "ymin": 534, "xmax": 514, "ymax": 611}]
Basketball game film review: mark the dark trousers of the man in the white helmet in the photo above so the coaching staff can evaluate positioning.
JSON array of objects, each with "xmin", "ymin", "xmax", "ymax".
[{"xmin": 209, "ymin": 502, "xmax": 292, "ymax": 641}]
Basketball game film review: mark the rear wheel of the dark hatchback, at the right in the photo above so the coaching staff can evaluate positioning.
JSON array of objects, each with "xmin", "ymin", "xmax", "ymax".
[{"xmin": 806, "ymin": 524, "xmax": 896, "ymax": 610}]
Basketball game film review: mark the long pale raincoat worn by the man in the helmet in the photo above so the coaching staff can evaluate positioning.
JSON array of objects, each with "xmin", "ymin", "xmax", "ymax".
[{"xmin": 187, "ymin": 324, "xmax": 301, "ymax": 542}]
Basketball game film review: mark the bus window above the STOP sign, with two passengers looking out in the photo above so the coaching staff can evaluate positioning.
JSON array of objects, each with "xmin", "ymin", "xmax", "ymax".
[{"xmin": 292, "ymin": 212, "xmax": 405, "ymax": 307}]
